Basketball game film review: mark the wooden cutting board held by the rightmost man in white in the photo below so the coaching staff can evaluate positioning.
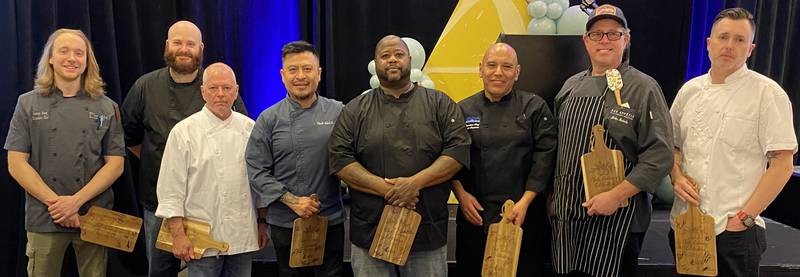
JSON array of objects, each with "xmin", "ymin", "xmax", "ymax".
[{"xmin": 673, "ymin": 176, "xmax": 717, "ymax": 276}]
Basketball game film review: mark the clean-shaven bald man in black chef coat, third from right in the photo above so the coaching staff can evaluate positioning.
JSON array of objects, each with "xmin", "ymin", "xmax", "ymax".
[{"xmin": 453, "ymin": 43, "xmax": 556, "ymax": 276}]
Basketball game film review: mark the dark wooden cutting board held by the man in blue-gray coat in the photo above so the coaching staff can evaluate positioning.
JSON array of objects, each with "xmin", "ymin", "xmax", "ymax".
[{"xmin": 289, "ymin": 194, "xmax": 328, "ymax": 268}]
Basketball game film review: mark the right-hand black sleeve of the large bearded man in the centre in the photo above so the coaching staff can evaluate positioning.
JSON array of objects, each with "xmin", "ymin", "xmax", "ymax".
[{"xmin": 437, "ymin": 93, "xmax": 472, "ymax": 169}]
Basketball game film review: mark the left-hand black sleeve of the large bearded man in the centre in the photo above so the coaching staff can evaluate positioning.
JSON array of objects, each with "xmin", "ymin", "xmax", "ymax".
[{"xmin": 328, "ymin": 104, "xmax": 357, "ymax": 174}]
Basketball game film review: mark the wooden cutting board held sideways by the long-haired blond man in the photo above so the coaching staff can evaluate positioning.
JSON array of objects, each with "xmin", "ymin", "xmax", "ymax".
[{"xmin": 80, "ymin": 206, "xmax": 142, "ymax": 252}]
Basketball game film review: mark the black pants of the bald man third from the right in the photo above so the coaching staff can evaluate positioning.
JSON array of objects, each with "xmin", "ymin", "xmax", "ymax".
[{"xmin": 454, "ymin": 210, "xmax": 550, "ymax": 277}]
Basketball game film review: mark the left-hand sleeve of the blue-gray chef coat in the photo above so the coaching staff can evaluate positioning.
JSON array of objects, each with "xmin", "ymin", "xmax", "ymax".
[{"xmin": 245, "ymin": 113, "xmax": 287, "ymax": 208}]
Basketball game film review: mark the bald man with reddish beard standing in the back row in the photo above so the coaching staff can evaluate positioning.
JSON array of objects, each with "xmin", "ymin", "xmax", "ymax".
[{"xmin": 122, "ymin": 21, "xmax": 247, "ymax": 277}]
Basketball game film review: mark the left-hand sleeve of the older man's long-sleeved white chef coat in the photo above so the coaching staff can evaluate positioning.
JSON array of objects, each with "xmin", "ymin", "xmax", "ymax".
[{"xmin": 156, "ymin": 128, "xmax": 191, "ymax": 218}]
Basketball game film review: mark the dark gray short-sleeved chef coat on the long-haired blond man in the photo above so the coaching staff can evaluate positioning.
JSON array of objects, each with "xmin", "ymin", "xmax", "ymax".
[{"xmin": 4, "ymin": 89, "xmax": 125, "ymax": 232}]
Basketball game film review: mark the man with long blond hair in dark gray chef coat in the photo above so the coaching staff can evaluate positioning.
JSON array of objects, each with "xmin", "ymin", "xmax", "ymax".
[{"xmin": 4, "ymin": 29, "xmax": 125, "ymax": 276}]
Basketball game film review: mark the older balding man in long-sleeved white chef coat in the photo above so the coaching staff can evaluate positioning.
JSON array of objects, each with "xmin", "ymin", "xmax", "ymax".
[{"xmin": 156, "ymin": 63, "xmax": 266, "ymax": 277}]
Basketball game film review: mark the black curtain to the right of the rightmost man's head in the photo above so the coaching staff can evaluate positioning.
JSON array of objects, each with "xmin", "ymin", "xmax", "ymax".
[{"xmin": 725, "ymin": 0, "xmax": 800, "ymax": 161}]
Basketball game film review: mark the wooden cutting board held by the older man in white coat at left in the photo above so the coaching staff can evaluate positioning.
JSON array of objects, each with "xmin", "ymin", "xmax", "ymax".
[{"xmin": 156, "ymin": 218, "xmax": 228, "ymax": 259}]
